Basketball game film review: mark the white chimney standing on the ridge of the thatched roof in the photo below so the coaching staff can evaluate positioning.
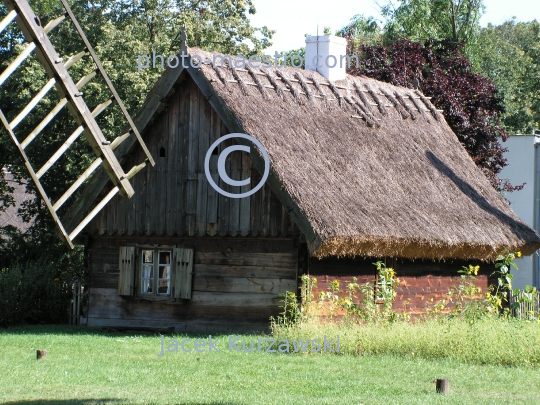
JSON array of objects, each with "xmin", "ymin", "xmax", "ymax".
[{"xmin": 306, "ymin": 35, "xmax": 347, "ymax": 82}]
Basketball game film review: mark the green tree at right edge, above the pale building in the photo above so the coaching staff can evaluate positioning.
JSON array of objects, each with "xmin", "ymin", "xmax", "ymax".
[{"xmin": 470, "ymin": 19, "xmax": 540, "ymax": 133}]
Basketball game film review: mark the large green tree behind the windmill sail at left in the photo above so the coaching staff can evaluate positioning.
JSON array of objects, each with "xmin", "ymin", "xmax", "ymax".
[{"xmin": 0, "ymin": 0, "xmax": 274, "ymax": 254}]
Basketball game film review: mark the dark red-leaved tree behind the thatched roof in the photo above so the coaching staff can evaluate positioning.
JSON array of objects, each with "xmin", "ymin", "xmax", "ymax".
[{"xmin": 348, "ymin": 40, "xmax": 523, "ymax": 191}]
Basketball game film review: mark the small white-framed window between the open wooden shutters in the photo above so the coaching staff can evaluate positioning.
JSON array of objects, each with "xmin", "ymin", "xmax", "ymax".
[{"xmin": 139, "ymin": 249, "xmax": 172, "ymax": 296}]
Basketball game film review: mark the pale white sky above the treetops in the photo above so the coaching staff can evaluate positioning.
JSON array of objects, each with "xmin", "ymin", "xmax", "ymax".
[{"xmin": 250, "ymin": 0, "xmax": 540, "ymax": 55}]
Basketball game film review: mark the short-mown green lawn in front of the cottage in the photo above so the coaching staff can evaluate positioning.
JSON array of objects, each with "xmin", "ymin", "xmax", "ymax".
[{"xmin": 0, "ymin": 326, "xmax": 540, "ymax": 405}]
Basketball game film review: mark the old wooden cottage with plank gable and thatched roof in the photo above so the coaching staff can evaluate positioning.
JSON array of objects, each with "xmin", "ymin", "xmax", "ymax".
[{"xmin": 66, "ymin": 48, "xmax": 540, "ymax": 333}]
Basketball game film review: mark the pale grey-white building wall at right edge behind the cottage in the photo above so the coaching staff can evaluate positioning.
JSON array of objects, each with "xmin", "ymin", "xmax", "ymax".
[{"xmin": 499, "ymin": 135, "xmax": 540, "ymax": 288}]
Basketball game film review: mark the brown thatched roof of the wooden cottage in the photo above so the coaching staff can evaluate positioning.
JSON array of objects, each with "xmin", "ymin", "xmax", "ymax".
[{"xmin": 66, "ymin": 48, "xmax": 540, "ymax": 260}]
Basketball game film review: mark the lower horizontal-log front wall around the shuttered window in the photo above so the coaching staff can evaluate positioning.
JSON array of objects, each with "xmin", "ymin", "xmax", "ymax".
[{"xmin": 88, "ymin": 235, "xmax": 298, "ymax": 333}]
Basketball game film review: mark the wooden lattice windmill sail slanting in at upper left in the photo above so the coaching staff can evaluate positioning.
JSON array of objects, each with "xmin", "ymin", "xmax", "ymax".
[{"xmin": 0, "ymin": 0, "xmax": 154, "ymax": 248}]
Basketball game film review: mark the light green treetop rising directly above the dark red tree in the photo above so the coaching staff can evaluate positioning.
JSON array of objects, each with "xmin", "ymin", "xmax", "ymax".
[{"xmin": 380, "ymin": 0, "xmax": 484, "ymax": 43}]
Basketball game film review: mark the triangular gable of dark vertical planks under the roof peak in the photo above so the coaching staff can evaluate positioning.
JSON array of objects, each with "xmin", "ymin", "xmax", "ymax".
[{"xmin": 86, "ymin": 80, "xmax": 300, "ymax": 237}]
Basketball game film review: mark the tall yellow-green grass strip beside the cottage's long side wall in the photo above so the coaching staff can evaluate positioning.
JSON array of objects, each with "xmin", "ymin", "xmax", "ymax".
[{"xmin": 274, "ymin": 317, "xmax": 540, "ymax": 367}]
